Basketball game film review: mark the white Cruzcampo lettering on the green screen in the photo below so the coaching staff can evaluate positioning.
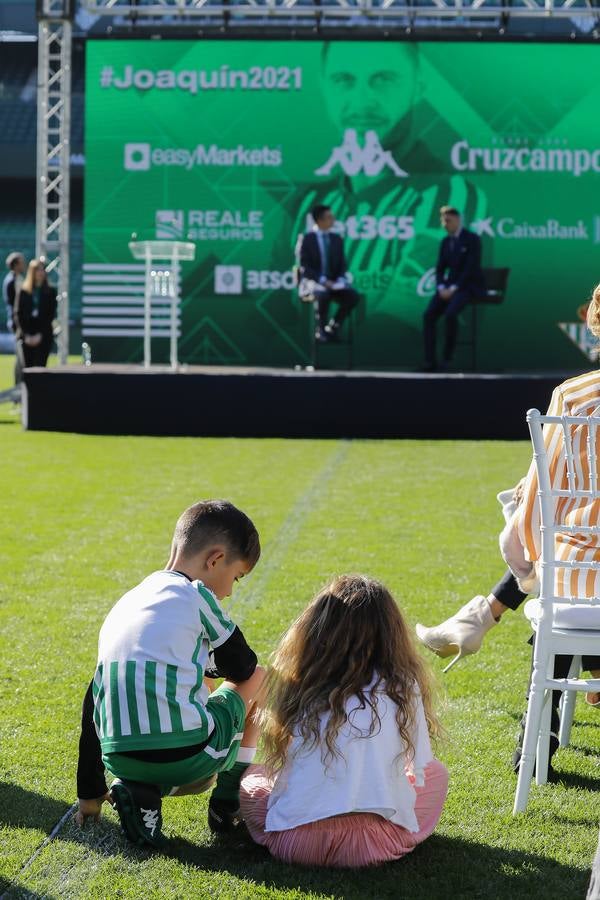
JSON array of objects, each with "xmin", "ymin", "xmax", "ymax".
[{"xmin": 450, "ymin": 140, "xmax": 600, "ymax": 178}]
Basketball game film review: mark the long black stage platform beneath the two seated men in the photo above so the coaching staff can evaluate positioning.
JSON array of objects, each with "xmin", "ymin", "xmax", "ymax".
[{"xmin": 23, "ymin": 364, "xmax": 574, "ymax": 440}]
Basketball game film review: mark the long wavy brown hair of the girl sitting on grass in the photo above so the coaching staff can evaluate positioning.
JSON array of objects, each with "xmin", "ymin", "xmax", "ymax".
[{"xmin": 263, "ymin": 575, "xmax": 441, "ymax": 771}]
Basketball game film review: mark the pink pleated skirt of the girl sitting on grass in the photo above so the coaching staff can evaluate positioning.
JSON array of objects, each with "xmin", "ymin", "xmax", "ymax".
[{"xmin": 240, "ymin": 759, "xmax": 448, "ymax": 868}]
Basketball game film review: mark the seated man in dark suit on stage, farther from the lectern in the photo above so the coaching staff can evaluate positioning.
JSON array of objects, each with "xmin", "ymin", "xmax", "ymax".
[{"xmin": 423, "ymin": 206, "xmax": 485, "ymax": 372}]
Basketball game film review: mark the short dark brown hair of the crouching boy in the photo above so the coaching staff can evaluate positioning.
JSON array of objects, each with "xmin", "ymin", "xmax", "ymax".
[{"xmin": 173, "ymin": 500, "xmax": 260, "ymax": 567}]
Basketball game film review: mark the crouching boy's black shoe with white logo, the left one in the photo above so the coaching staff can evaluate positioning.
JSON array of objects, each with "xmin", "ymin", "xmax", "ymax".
[{"xmin": 110, "ymin": 778, "xmax": 166, "ymax": 849}]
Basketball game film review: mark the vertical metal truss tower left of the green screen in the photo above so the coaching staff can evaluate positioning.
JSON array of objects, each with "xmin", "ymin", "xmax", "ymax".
[{"xmin": 35, "ymin": 0, "xmax": 71, "ymax": 363}]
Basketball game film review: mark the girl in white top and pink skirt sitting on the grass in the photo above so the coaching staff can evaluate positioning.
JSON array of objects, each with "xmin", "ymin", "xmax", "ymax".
[{"xmin": 240, "ymin": 575, "xmax": 448, "ymax": 867}]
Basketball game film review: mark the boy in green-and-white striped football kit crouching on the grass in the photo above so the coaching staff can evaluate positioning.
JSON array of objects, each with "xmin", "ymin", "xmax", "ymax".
[{"xmin": 76, "ymin": 500, "xmax": 265, "ymax": 847}]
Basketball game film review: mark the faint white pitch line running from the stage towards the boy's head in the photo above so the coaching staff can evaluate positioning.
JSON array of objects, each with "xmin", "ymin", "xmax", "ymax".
[{"xmin": 230, "ymin": 438, "xmax": 351, "ymax": 620}]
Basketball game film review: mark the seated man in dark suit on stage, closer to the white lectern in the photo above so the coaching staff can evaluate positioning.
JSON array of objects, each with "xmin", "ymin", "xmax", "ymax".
[{"xmin": 300, "ymin": 205, "xmax": 359, "ymax": 342}]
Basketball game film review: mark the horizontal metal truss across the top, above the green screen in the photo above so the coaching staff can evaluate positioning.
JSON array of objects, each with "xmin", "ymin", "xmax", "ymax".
[{"xmin": 81, "ymin": 0, "xmax": 600, "ymax": 24}]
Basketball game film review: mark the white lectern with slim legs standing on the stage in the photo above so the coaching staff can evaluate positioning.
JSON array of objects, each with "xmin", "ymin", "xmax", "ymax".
[{"xmin": 129, "ymin": 241, "xmax": 196, "ymax": 369}]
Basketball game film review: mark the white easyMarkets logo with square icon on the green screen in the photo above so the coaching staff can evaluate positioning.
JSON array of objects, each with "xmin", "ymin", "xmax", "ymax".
[{"xmin": 123, "ymin": 142, "xmax": 282, "ymax": 172}]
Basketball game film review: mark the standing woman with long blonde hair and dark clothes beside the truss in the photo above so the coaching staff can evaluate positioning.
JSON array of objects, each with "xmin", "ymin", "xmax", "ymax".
[{"xmin": 14, "ymin": 259, "xmax": 57, "ymax": 367}]
